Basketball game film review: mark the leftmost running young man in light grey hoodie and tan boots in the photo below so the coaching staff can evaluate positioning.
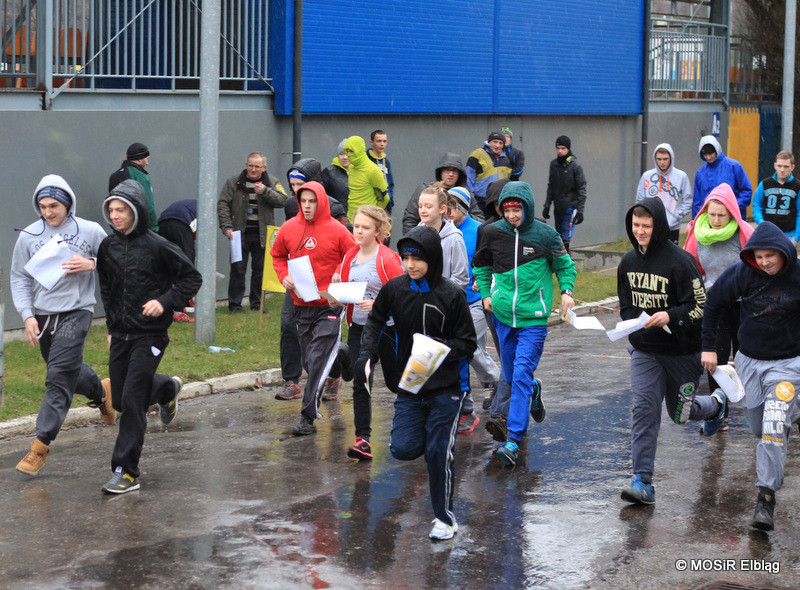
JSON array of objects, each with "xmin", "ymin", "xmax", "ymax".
[{"xmin": 11, "ymin": 174, "xmax": 116, "ymax": 475}]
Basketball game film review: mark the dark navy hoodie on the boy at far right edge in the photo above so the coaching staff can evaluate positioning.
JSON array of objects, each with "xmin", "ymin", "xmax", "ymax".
[{"xmin": 703, "ymin": 221, "xmax": 800, "ymax": 363}]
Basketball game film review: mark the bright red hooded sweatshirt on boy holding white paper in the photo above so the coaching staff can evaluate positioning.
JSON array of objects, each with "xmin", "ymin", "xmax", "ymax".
[{"xmin": 270, "ymin": 181, "xmax": 356, "ymax": 307}]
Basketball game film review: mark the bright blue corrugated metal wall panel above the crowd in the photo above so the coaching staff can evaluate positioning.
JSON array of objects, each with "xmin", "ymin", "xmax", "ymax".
[{"xmin": 270, "ymin": 0, "xmax": 643, "ymax": 115}]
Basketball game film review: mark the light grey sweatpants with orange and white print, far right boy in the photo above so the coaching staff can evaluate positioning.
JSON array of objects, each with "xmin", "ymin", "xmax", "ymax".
[{"xmin": 736, "ymin": 352, "xmax": 800, "ymax": 492}]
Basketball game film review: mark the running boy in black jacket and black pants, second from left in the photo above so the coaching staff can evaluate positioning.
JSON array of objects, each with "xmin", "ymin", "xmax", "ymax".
[{"xmin": 97, "ymin": 180, "xmax": 203, "ymax": 494}]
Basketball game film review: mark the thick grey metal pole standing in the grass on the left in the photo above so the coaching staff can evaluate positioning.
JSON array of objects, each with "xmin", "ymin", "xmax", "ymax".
[{"xmin": 194, "ymin": 0, "xmax": 220, "ymax": 344}]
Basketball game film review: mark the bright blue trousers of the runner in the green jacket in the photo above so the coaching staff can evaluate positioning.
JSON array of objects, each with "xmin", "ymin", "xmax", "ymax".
[{"xmin": 494, "ymin": 318, "xmax": 547, "ymax": 442}]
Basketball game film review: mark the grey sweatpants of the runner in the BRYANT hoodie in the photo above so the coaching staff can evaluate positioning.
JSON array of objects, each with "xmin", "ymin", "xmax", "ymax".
[{"xmin": 628, "ymin": 347, "xmax": 719, "ymax": 481}]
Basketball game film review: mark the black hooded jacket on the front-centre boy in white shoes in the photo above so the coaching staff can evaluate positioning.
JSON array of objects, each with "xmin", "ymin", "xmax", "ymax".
[{"xmin": 361, "ymin": 226, "xmax": 478, "ymax": 398}]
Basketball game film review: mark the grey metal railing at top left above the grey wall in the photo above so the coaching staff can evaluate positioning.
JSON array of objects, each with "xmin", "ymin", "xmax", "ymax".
[{"xmin": 0, "ymin": 0, "xmax": 271, "ymax": 97}]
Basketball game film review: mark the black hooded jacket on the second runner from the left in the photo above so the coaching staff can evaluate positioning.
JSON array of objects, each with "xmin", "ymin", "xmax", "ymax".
[{"xmin": 97, "ymin": 180, "xmax": 203, "ymax": 338}]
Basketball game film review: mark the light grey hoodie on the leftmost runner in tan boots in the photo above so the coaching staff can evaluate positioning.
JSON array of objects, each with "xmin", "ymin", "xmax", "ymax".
[{"xmin": 11, "ymin": 174, "xmax": 106, "ymax": 321}]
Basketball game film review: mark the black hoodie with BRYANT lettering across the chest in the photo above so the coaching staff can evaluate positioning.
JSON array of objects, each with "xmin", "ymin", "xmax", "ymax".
[{"xmin": 617, "ymin": 197, "xmax": 706, "ymax": 355}]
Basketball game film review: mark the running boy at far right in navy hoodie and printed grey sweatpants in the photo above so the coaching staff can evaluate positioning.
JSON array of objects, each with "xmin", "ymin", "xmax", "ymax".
[{"xmin": 702, "ymin": 221, "xmax": 800, "ymax": 531}]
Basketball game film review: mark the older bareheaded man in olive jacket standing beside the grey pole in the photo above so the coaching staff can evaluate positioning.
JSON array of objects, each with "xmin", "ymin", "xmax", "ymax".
[{"xmin": 217, "ymin": 152, "xmax": 286, "ymax": 313}]
